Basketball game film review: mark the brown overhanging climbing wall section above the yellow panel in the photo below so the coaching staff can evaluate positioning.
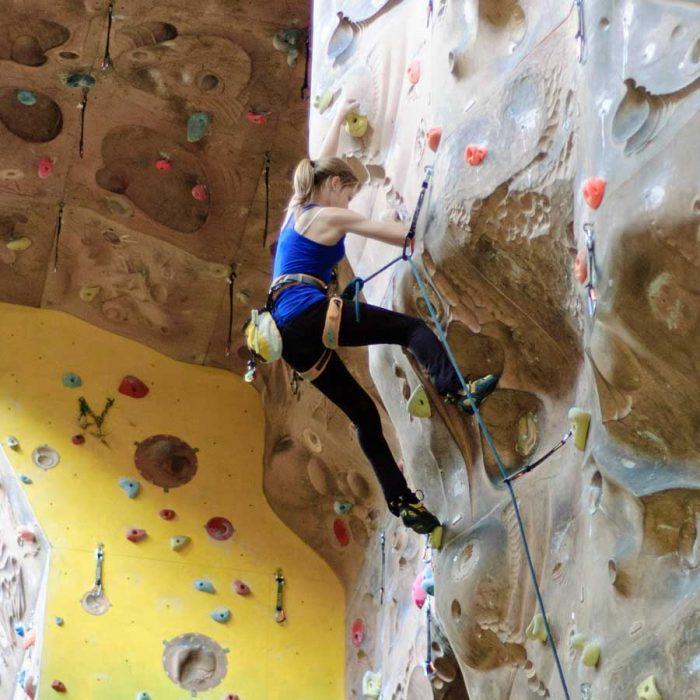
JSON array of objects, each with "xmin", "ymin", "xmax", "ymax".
[{"xmin": 0, "ymin": 0, "xmax": 309, "ymax": 372}]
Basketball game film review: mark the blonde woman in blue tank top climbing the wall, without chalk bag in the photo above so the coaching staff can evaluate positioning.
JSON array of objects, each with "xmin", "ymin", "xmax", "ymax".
[{"xmin": 270, "ymin": 101, "xmax": 498, "ymax": 534}]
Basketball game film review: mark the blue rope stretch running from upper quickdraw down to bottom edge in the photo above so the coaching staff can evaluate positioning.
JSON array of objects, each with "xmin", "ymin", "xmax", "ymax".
[{"xmin": 408, "ymin": 256, "xmax": 570, "ymax": 700}]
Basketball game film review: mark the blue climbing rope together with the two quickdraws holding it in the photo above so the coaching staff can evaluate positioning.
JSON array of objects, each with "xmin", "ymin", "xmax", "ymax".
[{"xmin": 343, "ymin": 167, "xmax": 571, "ymax": 700}]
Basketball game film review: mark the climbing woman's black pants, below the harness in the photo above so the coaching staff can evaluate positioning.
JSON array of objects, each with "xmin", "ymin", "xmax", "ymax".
[{"xmin": 280, "ymin": 299, "xmax": 461, "ymax": 502}]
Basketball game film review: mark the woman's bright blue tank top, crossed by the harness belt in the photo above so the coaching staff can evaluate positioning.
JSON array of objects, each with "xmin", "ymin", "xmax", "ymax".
[{"xmin": 272, "ymin": 204, "xmax": 345, "ymax": 326}]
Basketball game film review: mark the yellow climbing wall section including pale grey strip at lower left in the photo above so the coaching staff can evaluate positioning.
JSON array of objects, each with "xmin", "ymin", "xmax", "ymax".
[{"xmin": 0, "ymin": 304, "xmax": 344, "ymax": 700}]
